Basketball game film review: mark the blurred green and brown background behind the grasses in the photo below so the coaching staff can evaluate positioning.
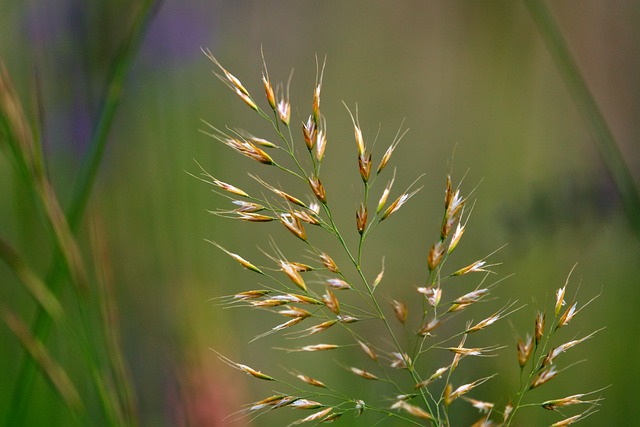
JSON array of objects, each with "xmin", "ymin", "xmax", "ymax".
[{"xmin": 0, "ymin": 0, "xmax": 640, "ymax": 426}]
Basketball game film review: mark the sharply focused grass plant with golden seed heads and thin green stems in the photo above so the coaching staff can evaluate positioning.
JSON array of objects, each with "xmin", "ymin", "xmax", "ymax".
[{"xmin": 197, "ymin": 50, "xmax": 600, "ymax": 426}]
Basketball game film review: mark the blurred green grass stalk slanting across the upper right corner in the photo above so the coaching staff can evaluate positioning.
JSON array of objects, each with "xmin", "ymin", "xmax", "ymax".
[{"xmin": 524, "ymin": 0, "xmax": 640, "ymax": 238}]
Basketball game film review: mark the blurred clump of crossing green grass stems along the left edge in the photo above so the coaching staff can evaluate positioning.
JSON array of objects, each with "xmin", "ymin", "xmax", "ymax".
[{"xmin": 0, "ymin": 0, "xmax": 158, "ymax": 426}]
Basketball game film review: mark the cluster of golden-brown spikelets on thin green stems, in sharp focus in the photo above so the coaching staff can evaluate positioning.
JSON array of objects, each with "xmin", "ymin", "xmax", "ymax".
[{"xmin": 199, "ymin": 51, "xmax": 600, "ymax": 427}]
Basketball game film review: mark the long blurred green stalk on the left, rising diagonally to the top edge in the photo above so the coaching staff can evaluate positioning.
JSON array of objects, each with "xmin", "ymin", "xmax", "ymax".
[{"xmin": 6, "ymin": 0, "xmax": 160, "ymax": 426}]
